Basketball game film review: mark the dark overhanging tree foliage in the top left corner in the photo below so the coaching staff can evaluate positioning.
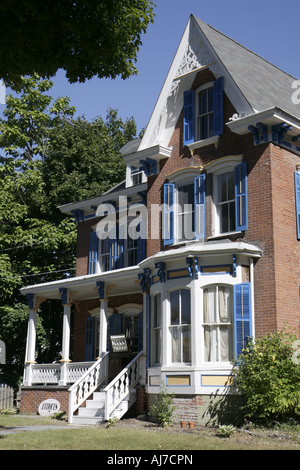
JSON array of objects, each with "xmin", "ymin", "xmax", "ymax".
[{"xmin": 0, "ymin": 0, "xmax": 154, "ymax": 86}]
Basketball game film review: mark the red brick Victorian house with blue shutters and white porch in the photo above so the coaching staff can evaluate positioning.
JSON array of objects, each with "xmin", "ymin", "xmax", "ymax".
[{"xmin": 21, "ymin": 15, "xmax": 300, "ymax": 423}]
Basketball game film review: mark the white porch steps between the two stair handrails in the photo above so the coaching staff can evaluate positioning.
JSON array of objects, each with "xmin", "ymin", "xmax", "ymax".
[{"xmin": 72, "ymin": 389, "xmax": 136, "ymax": 425}]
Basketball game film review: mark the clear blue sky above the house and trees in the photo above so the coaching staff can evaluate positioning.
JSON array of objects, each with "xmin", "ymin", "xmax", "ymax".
[{"xmin": 1, "ymin": 0, "xmax": 300, "ymax": 134}]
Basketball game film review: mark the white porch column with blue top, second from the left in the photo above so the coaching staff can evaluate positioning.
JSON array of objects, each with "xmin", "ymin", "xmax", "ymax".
[{"xmin": 59, "ymin": 288, "xmax": 71, "ymax": 385}]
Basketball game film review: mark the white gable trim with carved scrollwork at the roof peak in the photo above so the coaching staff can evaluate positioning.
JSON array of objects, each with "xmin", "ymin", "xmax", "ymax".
[{"xmin": 139, "ymin": 15, "xmax": 253, "ymax": 150}]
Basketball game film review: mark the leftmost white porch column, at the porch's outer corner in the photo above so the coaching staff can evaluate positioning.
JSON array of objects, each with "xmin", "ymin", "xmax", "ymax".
[{"xmin": 24, "ymin": 294, "xmax": 45, "ymax": 386}]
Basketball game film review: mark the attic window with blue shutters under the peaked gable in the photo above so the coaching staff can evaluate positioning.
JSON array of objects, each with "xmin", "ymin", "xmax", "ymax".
[{"xmin": 183, "ymin": 77, "xmax": 223, "ymax": 145}]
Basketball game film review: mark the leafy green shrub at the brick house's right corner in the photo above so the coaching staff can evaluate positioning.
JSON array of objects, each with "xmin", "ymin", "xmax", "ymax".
[{"xmin": 233, "ymin": 331, "xmax": 300, "ymax": 423}]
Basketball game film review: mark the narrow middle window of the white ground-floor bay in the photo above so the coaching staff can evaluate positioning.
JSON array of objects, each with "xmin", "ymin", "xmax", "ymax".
[{"xmin": 170, "ymin": 289, "xmax": 191, "ymax": 363}]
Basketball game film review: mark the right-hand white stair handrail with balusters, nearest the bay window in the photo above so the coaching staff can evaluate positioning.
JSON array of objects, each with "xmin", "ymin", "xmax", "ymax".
[{"xmin": 103, "ymin": 351, "xmax": 143, "ymax": 421}]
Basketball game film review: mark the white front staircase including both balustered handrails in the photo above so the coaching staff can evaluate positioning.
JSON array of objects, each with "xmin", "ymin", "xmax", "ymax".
[{"xmin": 68, "ymin": 352, "xmax": 143, "ymax": 425}]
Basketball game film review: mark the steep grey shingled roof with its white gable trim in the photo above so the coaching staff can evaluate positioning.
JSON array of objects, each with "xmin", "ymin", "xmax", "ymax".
[{"xmin": 138, "ymin": 15, "xmax": 300, "ymax": 151}]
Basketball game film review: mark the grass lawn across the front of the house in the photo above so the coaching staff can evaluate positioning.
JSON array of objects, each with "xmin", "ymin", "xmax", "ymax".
[{"xmin": 0, "ymin": 415, "xmax": 300, "ymax": 451}]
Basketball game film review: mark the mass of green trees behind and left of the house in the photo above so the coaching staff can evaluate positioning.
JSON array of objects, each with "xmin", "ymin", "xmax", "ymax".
[{"xmin": 0, "ymin": 75, "xmax": 136, "ymax": 385}]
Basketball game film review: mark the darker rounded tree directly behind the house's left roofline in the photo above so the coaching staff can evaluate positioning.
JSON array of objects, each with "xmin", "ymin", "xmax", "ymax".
[{"xmin": 43, "ymin": 109, "xmax": 136, "ymax": 211}]
